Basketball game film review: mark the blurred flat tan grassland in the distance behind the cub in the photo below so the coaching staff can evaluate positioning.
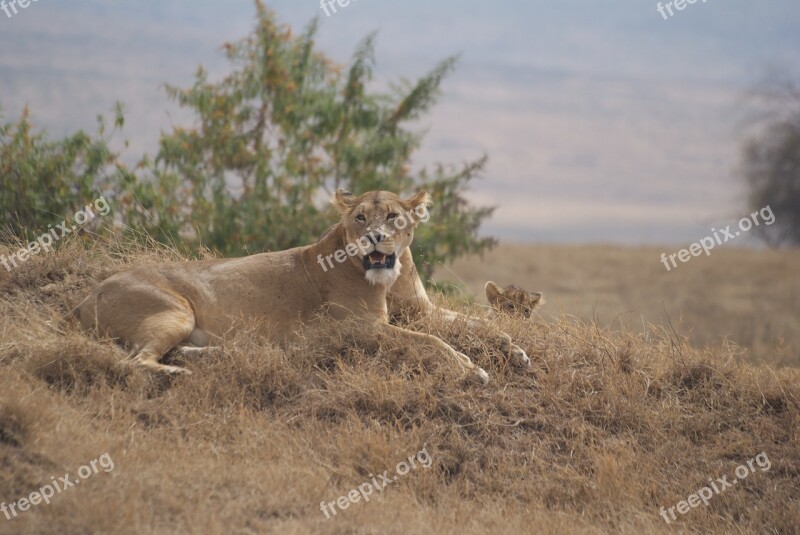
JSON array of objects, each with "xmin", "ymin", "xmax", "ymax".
[{"xmin": 436, "ymin": 244, "xmax": 800, "ymax": 366}]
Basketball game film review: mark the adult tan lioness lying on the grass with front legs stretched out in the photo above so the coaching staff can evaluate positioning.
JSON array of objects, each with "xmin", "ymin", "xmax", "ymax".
[{"xmin": 75, "ymin": 190, "xmax": 530, "ymax": 384}]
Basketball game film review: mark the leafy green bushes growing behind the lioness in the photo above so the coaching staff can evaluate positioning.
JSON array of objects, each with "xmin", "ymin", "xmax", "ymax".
[{"xmin": 0, "ymin": 1, "xmax": 494, "ymax": 279}]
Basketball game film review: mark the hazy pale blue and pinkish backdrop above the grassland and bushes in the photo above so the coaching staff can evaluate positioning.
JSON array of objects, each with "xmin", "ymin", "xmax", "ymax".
[{"xmin": 0, "ymin": 0, "xmax": 800, "ymax": 245}]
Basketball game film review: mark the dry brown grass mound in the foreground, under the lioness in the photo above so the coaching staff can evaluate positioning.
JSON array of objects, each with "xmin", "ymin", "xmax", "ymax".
[{"xmin": 0, "ymin": 241, "xmax": 800, "ymax": 534}]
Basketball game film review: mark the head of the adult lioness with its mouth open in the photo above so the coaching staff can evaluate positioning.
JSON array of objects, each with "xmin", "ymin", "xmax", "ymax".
[{"xmin": 331, "ymin": 190, "xmax": 430, "ymax": 287}]
